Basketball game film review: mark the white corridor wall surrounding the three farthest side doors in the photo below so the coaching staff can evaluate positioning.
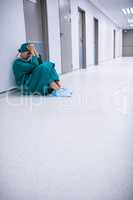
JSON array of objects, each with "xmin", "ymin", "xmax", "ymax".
[{"xmin": 71, "ymin": 0, "xmax": 122, "ymax": 69}]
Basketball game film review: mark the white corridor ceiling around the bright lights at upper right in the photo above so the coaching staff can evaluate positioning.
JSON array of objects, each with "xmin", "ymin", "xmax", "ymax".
[{"xmin": 90, "ymin": 0, "xmax": 133, "ymax": 29}]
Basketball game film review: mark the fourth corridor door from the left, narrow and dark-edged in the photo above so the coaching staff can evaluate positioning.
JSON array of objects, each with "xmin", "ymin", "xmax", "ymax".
[{"xmin": 94, "ymin": 18, "xmax": 99, "ymax": 65}]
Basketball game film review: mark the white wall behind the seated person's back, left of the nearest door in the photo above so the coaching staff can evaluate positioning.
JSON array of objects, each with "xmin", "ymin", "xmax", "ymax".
[{"xmin": 0, "ymin": 0, "xmax": 25, "ymax": 91}]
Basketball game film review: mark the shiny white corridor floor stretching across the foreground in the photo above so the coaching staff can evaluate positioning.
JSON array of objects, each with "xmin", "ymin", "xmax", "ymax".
[{"xmin": 0, "ymin": 58, "xmax": 133, "ymax": 200}]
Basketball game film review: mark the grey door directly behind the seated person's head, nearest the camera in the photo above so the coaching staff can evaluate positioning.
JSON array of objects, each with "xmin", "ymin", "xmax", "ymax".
[{"xmin": 23, "ymin": 0, "xmax": 49, "ymax": 60}]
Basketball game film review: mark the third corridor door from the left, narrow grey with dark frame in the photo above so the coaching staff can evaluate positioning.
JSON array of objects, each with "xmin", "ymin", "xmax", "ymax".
[{"xmin": 78, "ymin": 8, "xmax": 86, "ymax": 68}]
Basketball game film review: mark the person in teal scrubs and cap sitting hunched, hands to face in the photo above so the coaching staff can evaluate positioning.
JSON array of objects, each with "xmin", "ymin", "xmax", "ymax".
[{"xmin": 13, "ymin": 43, "xmax": 71, "ymax": 96}]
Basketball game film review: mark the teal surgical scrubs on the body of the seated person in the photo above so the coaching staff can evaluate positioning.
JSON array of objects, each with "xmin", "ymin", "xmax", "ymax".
[{"xmin": 13, "ymin": 56, "xmax": 59, "ymax": 95}]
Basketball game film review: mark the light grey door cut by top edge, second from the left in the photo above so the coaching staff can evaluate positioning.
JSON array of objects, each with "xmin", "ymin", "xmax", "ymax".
[{"xmin": 59, "ymin": 0, "xmax": 72, "ymax": 73}]
